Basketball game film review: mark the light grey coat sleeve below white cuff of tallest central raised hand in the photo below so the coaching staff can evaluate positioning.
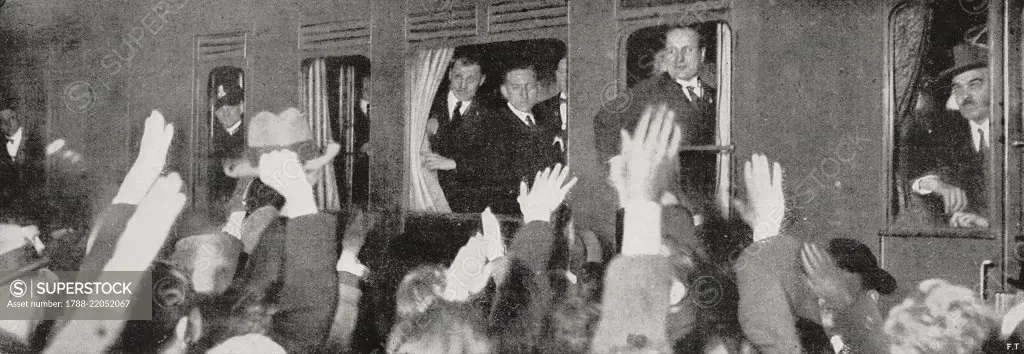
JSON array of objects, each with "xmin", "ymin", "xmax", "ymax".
[{"xmin": 591, "ymin": 256, "xmax": 672, "ymax": 353}]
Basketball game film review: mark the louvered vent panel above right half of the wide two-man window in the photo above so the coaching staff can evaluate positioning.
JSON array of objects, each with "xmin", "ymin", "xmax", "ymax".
[{"xmin": 487, "ymin": 0, "xmax": 568, "ymax": 33}]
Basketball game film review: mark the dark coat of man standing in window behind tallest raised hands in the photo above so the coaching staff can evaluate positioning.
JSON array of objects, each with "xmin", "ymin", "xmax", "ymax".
[{"xmin": 594, "ymin": 74, "xmax": 717, "ymax": 215}]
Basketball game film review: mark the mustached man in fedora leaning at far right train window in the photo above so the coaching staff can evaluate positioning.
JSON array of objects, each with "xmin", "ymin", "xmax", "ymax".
[{"xmin": 909, "ymin": 28, "xmax": 998, "ymax": 227}]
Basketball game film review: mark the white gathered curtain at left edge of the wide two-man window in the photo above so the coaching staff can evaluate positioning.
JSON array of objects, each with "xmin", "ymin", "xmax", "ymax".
[{"xmin": 406, "ymin": 48, "xmax": 455, "ymax": 213}]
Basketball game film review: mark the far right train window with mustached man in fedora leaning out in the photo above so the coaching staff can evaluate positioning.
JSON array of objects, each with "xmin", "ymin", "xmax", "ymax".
[{"xmin": 889, "ymin": 1, "xmax": 1002, "ymax": 235}]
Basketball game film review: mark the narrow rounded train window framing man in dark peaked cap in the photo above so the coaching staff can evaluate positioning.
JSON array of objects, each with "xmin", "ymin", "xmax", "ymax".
[{"xmin": 199, "ymin": 67, "xmax": 246, "ymax": 210}]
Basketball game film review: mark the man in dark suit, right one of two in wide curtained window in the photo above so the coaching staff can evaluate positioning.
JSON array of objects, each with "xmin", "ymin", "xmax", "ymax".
[{"xmin": 474, "ymin": 64, "xmax": 561, "ymax": 214}]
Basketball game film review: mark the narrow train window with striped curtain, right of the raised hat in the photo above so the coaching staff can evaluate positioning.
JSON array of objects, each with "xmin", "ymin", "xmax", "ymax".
[{"xmin": 302, "ymin": 55, "xmax": 371, "ymax": 211}]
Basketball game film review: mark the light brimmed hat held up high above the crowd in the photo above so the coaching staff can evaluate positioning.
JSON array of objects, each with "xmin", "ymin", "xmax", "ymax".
[{"xmin": 225, "ymin": 107, "xmax": 341, "ymax": 178}]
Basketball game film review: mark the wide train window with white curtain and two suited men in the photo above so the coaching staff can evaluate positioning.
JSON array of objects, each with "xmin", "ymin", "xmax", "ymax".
[{"xmin": 408, "ymin": 39, "xmax": 569, "ymax": 215}]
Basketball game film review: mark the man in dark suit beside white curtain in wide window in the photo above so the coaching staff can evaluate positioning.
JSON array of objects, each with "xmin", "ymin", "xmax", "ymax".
[{"xmin": 423, "ymin": 55, "xmax": 484, "ymax": 213}]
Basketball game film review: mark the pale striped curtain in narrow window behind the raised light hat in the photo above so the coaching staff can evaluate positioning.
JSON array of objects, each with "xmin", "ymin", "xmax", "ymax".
[{"xmin": 303, "ymin": 58, "xmax": 341, "ymax": 211}]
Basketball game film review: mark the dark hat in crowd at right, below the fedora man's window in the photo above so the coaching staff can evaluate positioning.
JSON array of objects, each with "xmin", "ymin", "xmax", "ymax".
[{"xmin": 828, "ymin": 238, "xmax": 896, "ymax": 295}]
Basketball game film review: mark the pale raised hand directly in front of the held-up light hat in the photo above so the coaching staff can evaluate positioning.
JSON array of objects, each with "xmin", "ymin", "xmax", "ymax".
[{"xmin": 259, "ymin": 149, "xmax": 317, "ymax": 218}]
